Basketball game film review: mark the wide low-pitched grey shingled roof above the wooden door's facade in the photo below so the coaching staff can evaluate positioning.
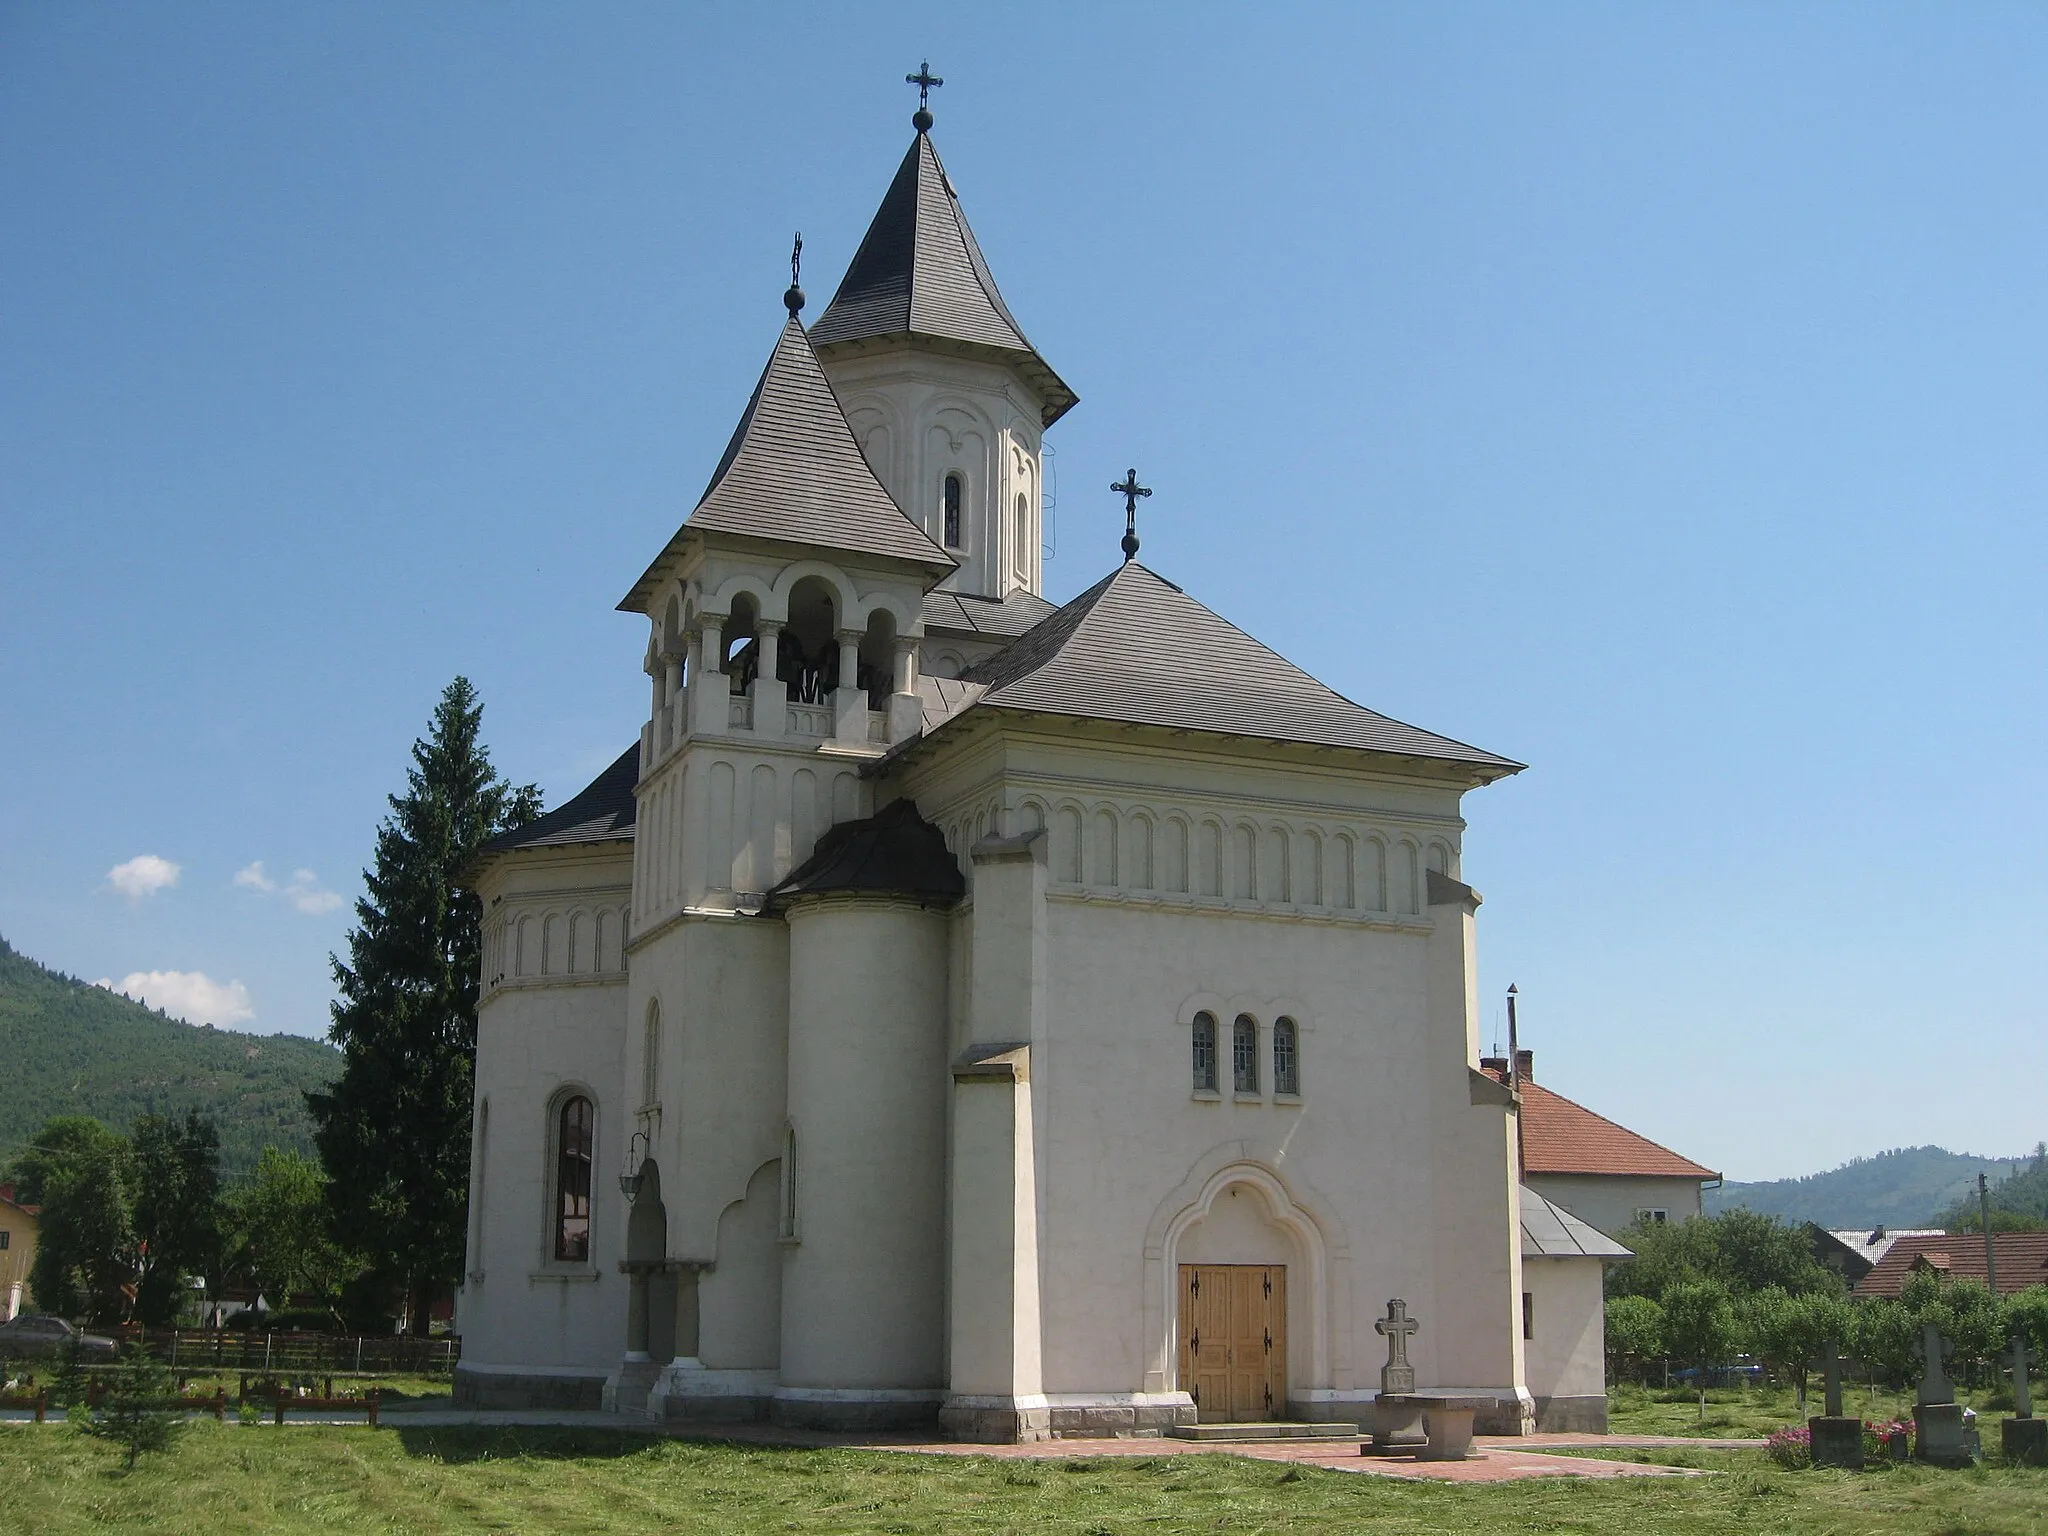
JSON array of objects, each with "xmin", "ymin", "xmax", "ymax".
[{"xmin": 942, "ymin": 561, "xmax": 1522, "ymax": 780}]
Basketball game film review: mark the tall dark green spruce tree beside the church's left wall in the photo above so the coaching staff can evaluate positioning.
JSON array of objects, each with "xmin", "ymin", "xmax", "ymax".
[{"xmin": 307, "ymin": 678, "xmax": 541, "ymax": 1331}]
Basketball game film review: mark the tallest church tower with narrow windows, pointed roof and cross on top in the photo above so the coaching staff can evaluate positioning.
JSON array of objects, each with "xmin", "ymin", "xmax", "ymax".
[{"xmin": 811, "ymin": 68, "xmax": 1075, "ymax": 598}]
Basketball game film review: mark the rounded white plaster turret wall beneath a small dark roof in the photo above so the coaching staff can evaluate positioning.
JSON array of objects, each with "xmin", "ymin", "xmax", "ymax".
[{"xmin": 782, "ymin": 897, "xmax": 948, "ymax": 1389}]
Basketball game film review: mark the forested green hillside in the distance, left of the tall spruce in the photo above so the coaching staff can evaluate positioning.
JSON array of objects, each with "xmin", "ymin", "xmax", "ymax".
[{"xmin": 0, "ymin": 938, "xmax": 342, "ymax": 1171}]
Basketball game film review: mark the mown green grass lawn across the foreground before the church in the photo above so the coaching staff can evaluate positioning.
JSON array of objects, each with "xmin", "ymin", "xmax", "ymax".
[{"xmin": 0, "ymin": 1423, "xmax": 2048, "ymax": 1536}]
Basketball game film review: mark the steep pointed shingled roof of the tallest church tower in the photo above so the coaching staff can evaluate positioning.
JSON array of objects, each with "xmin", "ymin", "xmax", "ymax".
[{"xmin": 811, "ymin": 133, "xmax": 1075, "ymax": 426}]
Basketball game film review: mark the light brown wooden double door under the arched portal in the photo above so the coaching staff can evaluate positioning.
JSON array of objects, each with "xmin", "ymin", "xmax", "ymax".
[{"xmin": 1180, "ymin": 1264, "xmax": 1286, "ymax": 1423}]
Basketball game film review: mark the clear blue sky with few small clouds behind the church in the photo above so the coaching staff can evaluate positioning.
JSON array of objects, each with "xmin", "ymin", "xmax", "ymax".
[{"xmin": 0, "ymin": 2, "xmax": 2048, "ymax": 1178}]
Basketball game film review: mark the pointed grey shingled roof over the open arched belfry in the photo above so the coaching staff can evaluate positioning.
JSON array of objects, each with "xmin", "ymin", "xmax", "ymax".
[{"xmin": 618, "ymin": 315, "xmax": 954, "ymax": 612}]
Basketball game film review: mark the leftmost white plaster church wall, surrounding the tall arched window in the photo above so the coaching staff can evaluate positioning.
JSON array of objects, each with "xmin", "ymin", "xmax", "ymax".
[{"xmin": 459, "ymin": 844, "xmax": 629, "ymax": 1370}]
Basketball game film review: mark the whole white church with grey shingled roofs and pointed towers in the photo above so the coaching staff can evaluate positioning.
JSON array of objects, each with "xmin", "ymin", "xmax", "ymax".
[{"xmin": 457, "ymin": 90, "xmax": 1622, "ymax": 1442}]
